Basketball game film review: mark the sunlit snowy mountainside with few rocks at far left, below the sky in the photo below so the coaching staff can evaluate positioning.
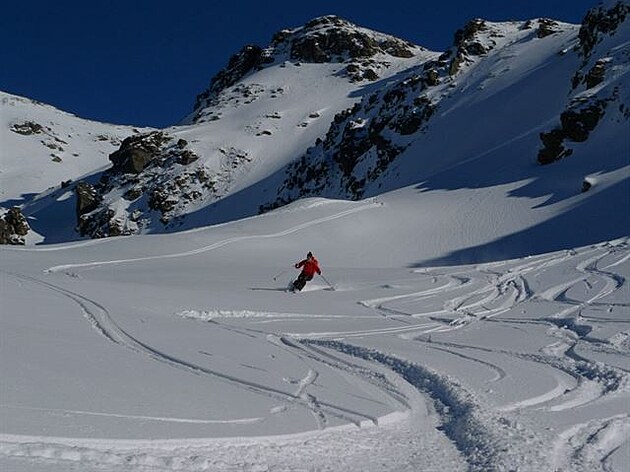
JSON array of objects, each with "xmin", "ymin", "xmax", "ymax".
[{"xmin": 0, "ymin": 92, "xmax": 146, "ymax": 206}]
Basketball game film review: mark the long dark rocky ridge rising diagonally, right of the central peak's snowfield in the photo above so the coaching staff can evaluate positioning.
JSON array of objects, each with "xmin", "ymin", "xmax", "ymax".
[{"xmin": 259, "ymin": 19, "xmax": 524, "ymax": 212}]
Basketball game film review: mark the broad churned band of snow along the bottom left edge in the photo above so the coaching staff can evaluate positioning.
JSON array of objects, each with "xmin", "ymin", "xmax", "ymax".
[{"xmin": 0, "ymin": 414, "xmax": 465, "ymax": 472}]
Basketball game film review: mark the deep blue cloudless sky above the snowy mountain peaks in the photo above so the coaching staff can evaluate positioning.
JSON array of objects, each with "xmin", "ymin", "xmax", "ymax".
[{"xmin": 0, "ymin": 0, "xmax": 598, "ymax": 127}]
